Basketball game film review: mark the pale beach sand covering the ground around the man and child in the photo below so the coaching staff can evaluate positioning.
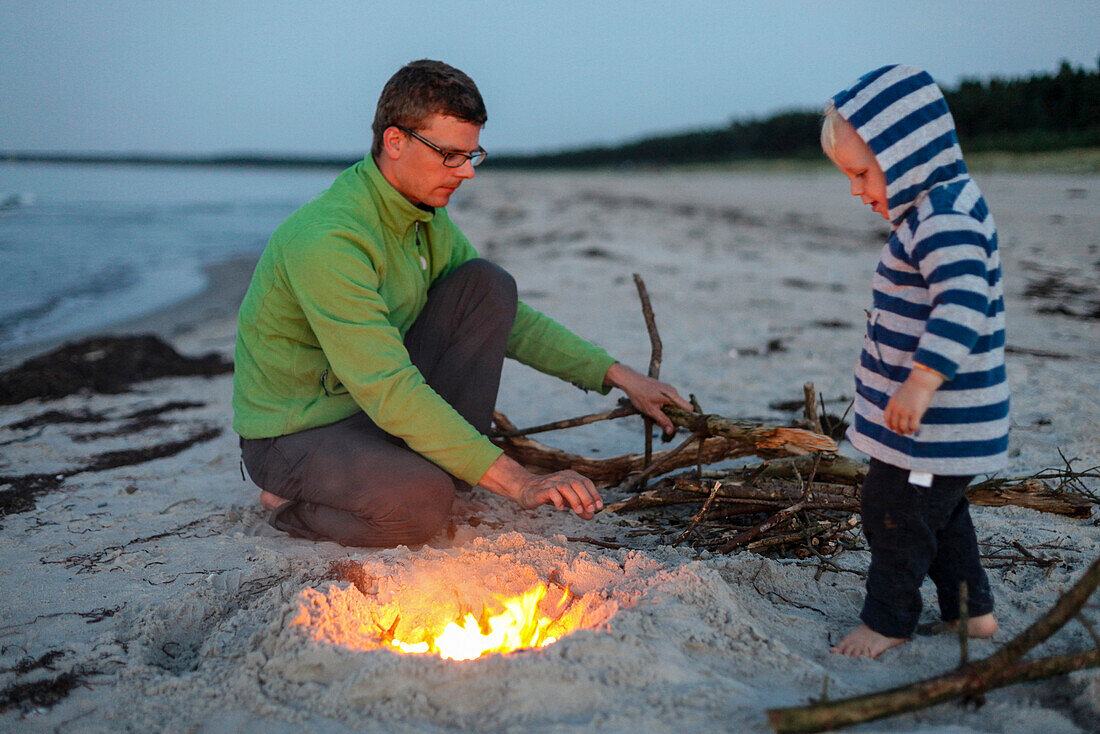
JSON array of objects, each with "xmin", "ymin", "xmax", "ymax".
[{"xmin": 0, "ymin": 172, "xmax": 1100, "ymax": 734}]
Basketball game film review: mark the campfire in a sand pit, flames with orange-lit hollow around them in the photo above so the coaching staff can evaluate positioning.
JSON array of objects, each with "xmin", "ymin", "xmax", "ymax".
[{"xmin": 292, "ymin": 567, "xmax": 618, "ymax": 660}]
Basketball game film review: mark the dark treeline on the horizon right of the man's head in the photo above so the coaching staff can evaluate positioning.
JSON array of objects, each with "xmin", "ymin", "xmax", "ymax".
[{"xmin": 485, "ymin": 62, "xmax": 1100, "ymax": 168}]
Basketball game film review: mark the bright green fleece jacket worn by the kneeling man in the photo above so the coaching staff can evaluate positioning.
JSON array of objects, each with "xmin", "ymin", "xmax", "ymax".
[{"xmin": 233, "ymin": 156, "xmax": 614, "ymax": 484}]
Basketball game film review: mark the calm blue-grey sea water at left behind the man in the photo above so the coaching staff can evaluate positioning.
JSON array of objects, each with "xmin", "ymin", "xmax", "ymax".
[{"xmin": 0, "ymin": 163, "xmax": 339, "ymax": 353}]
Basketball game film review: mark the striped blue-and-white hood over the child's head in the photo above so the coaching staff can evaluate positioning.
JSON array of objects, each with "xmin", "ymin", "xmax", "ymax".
[{"xmin": 833, "ymin": 65, "xmax": 967, "ymax": 228}]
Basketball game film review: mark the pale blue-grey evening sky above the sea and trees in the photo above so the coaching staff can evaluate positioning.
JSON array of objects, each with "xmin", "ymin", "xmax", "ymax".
[{"xmin": 0, "ymin": 0, "xmax": 1100, "ymax": 155}]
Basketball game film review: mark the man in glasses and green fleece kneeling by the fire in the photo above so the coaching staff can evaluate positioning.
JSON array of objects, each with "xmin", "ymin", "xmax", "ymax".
[{"xmin": 233, "ymin": 61, "xmax": 690, "ymax": 546}]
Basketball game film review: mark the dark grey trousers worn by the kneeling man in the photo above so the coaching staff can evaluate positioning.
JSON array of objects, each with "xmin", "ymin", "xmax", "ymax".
[{"xmin": 241, "ymin": 260, "xmax": 517, "ymax": 547}]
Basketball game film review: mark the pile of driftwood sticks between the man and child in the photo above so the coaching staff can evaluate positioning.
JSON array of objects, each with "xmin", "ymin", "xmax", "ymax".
[{"xmin": 491, "ymin": 274, "xmax": 1100, "ymax": 569}]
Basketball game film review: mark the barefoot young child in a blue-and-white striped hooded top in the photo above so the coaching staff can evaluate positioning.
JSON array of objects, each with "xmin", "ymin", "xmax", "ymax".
[{"xmin": 822, "ymin": 66, "xmax": 1009, "ymax": 658}]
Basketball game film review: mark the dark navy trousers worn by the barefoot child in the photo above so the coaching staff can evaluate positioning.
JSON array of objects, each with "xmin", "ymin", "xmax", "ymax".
[{"xmin": 859, "ymin": 459, "xmax": 993, "ymax": 637}]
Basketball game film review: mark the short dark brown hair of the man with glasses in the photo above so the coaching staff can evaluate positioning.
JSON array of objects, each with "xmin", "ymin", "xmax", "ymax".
[{"xmin": 371, "ymin": 58, "xmax": 488, "ymax": 155}]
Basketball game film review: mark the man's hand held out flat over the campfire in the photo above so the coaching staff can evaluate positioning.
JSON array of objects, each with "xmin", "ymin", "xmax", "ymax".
[{"xmin": 477, "ymin": 453, "xmax": 604, "ymax": 519}]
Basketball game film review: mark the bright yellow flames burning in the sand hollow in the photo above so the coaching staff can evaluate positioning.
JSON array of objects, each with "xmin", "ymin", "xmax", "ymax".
[{"xmin": 380, "ymin": 583, "xmax": 572, "ymax": 660}]
